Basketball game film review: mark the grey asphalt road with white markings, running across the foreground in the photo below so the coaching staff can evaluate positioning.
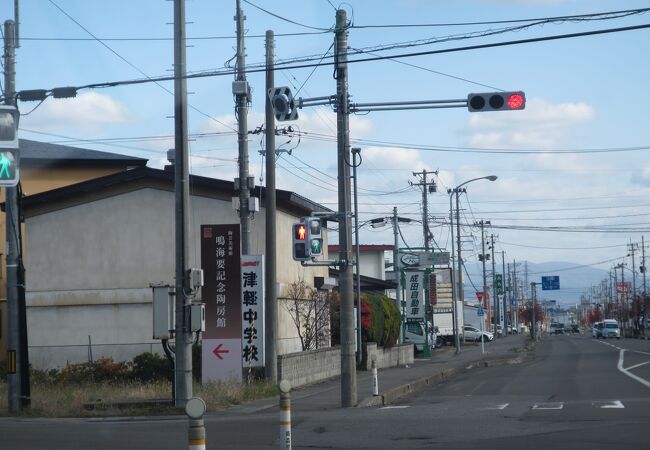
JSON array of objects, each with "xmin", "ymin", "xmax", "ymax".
[{"xmin": 0, "ymin": 335, "xmax": 650, "ymax": 450}]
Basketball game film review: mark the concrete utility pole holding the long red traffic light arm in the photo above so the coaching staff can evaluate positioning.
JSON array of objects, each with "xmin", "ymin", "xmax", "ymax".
[{"xmin": 334, "ymin": 9, "xmax": 357, "ymax": 408}]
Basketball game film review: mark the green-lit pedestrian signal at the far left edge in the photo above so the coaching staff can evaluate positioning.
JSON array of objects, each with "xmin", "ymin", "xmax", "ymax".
[{"xmin": 0, "ymin": 105, "xmax": 20, "ymax": 187}]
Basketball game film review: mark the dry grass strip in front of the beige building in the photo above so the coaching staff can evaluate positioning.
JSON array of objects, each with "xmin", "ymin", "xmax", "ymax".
[{"xmin": 0, "ymin": 381, "xmax": 278, "ymax": 417}]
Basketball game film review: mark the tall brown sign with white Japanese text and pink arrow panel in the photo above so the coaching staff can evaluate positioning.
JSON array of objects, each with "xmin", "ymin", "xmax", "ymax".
[{"xmin": 201, "ymin": 224, "xmax": 242, "ymax": 382}]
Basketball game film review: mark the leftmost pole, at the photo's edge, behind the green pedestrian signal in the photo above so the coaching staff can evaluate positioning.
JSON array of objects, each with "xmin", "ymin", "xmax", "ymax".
[{"xmin": 4, "ymin": 20, "xmax": 23, "ymax": 413}]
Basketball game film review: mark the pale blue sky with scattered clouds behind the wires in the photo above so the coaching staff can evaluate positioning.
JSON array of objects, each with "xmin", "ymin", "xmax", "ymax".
[{"xmin": 5, "ymin": 0, "xmax": 650, "ymax": 302}]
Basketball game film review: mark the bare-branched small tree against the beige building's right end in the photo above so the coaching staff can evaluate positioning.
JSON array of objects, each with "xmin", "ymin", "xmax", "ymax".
[{"xmin": 282, "ymin": 280, "xmax": 330, "ymax": 351}]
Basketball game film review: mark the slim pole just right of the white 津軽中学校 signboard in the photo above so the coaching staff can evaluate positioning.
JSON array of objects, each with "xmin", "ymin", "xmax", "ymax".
[{"xmin": 264, "ymin": 30, "xmax": 278, "ymax": 383}]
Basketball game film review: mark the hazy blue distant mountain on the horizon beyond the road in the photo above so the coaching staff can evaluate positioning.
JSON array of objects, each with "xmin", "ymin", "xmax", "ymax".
[{"xmin": 465, "ymin": 261, "xmax": 609, "ymax": 306}]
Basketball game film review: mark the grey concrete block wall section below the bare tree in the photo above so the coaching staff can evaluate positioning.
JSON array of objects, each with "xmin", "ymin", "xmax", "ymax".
[{"xmin": 278, "ymin": 347, "xmax": 341, "ymax": 388}]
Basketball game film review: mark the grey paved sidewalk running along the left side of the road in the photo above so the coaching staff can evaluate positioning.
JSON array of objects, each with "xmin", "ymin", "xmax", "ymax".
[{"xmin": 229, "ymin": 334, "xmax": 531, "ymax": 414}]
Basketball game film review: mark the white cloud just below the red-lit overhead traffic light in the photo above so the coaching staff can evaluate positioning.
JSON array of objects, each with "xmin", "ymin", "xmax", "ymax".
[{"xmin": 467, "ymin": 99, "xmax": 595, "ymax": 149}]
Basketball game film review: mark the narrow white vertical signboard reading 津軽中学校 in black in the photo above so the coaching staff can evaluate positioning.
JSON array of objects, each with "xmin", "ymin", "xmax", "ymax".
[{"xmin": 241, "ymin": 255, "xmax": 264, "ymax": 369}]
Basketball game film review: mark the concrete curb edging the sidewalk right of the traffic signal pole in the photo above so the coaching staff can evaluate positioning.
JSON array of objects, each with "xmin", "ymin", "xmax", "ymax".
[{"xmin": 357, "ymin": 355, "xmax": 527, "ymax": 408}]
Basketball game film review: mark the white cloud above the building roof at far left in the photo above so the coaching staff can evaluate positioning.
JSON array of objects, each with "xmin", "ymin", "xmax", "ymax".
[{"xmin": 21, "ymin": 92, "xmax": 131, "ymax": 134}]
